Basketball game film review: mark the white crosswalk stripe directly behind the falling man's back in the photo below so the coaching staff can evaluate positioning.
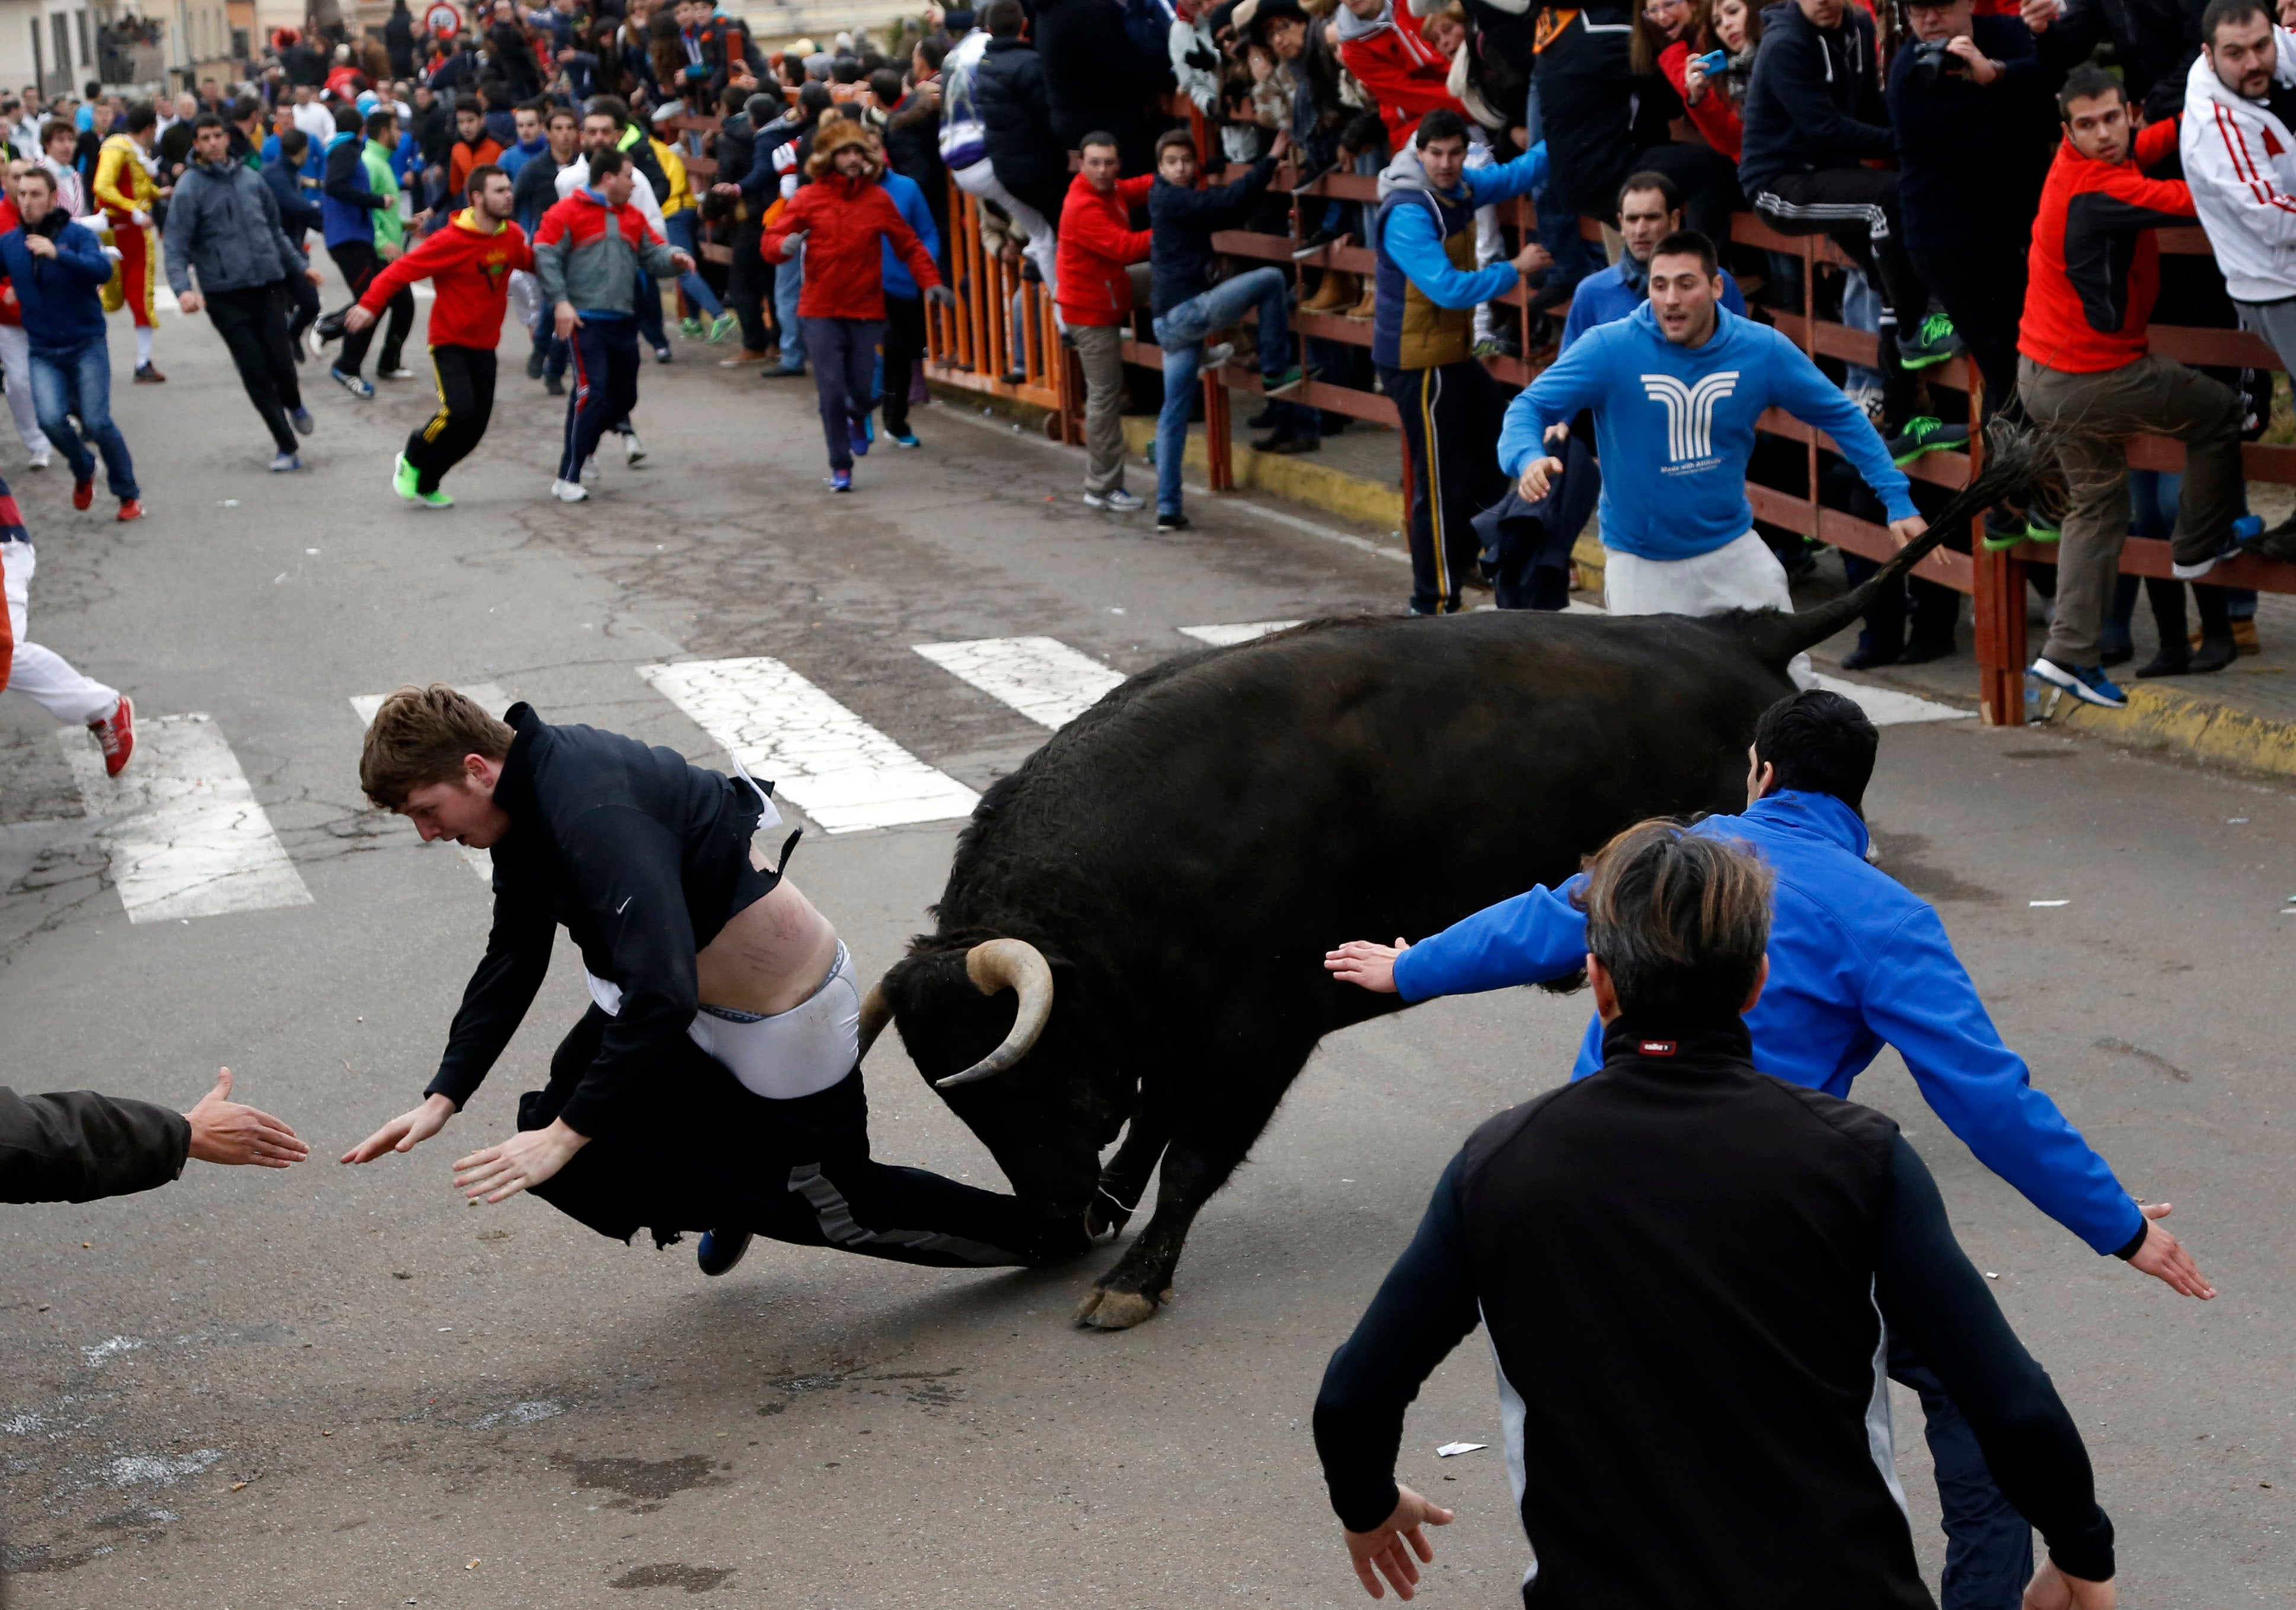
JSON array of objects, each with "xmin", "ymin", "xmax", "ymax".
[{"xmin": 638, "ymin": 657, "xmax": 981, "ymax": 833}]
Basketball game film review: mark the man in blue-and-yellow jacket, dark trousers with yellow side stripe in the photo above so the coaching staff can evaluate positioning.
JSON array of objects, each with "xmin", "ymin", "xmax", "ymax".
[{"xmin": 1371, "ymin": 108, "xmax": 1554, "ymax": 615}]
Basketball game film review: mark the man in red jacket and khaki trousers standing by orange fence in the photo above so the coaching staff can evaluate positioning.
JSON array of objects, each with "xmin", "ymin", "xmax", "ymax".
[{"xmin": 1058, "ymin": 133, "xmax": 1155, "ymax": 515}]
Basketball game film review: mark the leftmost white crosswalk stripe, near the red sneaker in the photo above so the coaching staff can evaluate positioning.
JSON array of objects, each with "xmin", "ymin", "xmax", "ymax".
[{"xmin": 60, "ymin": 714, "xmax": 310, "ymax": 924}]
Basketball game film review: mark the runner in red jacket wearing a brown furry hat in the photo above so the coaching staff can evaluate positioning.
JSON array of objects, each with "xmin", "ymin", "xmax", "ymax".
[{"xmin": 758, "ymin": 113, "xmax": 955, "ymax": 491}]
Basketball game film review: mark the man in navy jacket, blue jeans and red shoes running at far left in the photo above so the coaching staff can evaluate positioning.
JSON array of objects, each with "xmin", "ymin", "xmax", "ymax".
[{"xmin": 0, "ymin": 168, "xmax": 142, "ymax": 519}]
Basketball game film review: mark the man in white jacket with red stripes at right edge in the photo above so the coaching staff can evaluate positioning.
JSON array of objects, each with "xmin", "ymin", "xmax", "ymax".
[{"xmin": 2177, "ymin": 0, "xmax": 2296, "ymax": 567}]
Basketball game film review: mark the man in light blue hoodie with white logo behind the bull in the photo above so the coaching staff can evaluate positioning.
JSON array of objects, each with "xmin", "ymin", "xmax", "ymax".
[{"xmin": 1499, "ymin": 229, "xmax": 1928, "ymax": 686}]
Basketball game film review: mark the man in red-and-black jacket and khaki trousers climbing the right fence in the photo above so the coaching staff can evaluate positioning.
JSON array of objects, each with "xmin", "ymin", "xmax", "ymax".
[{"xmin": 2016, "ymin": 66, "xmax": 2246, "ymax": 710}]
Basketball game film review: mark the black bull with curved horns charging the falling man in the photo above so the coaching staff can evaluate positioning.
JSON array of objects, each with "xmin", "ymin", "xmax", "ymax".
[{"xmin": 863, "ymin": 452, "xmax": 2016, "ymax": 1327}]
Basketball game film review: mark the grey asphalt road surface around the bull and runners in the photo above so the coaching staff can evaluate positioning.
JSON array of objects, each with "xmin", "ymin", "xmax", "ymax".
[{"xmin": 0, "ymin": 296, "xmax": 2296, "ymax": 1610}]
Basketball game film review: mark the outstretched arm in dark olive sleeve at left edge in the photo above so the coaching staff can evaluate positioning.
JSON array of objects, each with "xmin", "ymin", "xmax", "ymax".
[{"xmin": 0, "ymin": 1068, "xmax": 310, "ymax": 1201}]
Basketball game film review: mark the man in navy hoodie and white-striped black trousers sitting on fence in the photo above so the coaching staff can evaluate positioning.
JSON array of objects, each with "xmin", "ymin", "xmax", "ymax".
[{"xmin": 1738, "ymin": 0, "xmax": 1961, "ymax": 379}]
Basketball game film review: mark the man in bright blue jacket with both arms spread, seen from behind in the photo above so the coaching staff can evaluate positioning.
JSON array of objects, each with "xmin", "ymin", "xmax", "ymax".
[{"xmin": 1325, "ymin": 691, "xmax": 2215, "ymax": 1610}]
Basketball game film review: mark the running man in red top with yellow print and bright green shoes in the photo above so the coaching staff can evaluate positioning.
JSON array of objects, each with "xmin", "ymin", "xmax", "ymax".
[{"xmin": 342, "ymin": 163, "xmax": 535, "ymax": 507}]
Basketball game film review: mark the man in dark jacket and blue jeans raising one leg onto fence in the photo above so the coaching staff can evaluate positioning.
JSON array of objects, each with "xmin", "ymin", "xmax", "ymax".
[{"xmin": 1148, "ymin": 129, "xmax": 1307, "ymax": 531}]
